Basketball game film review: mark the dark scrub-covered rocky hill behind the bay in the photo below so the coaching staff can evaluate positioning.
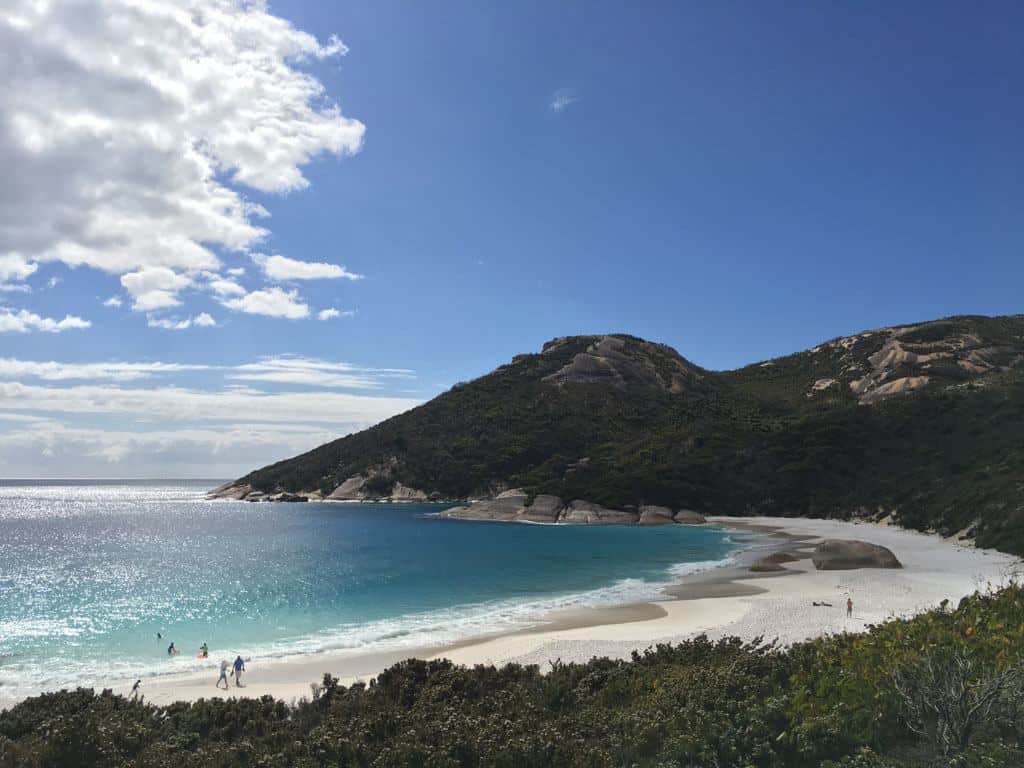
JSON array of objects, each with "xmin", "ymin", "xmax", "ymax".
[{"xmin": 238, "ymin": 315, "xmax": 1024, "ymax": 554}]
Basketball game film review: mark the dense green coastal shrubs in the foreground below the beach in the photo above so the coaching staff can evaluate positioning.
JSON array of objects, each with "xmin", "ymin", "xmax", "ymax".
[{"xmin": 0, "ymin": 587, "xmax": 1024, "ymax": 768}]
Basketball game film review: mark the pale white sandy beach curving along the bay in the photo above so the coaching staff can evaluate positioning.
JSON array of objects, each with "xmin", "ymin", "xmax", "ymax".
[{"xmin": 6, "ymin": 517, "xmax": 1022, "ymax": 703}]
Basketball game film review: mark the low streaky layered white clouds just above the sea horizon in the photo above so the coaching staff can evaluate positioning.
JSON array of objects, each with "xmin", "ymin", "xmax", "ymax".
[{"xmin": 0, "ymin": 354, "xmax": 420, "ymax": 479}]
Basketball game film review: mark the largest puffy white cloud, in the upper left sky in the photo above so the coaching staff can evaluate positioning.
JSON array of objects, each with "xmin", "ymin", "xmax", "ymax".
[{"xmin": 0, "ymin": 0, "xmax": 365, "ymax": 310}]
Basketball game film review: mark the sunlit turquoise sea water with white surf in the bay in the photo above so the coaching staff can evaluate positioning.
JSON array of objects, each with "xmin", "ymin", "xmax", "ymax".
[{"xmin": 0, "ymin": 481, "xmax": 736, "ymax": 697}]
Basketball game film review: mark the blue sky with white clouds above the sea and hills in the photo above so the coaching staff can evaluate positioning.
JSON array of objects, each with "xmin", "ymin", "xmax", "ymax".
[{"xmin": 0, "ymin": 0, "xmax": 1024, "ymax": 478}]
